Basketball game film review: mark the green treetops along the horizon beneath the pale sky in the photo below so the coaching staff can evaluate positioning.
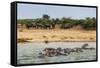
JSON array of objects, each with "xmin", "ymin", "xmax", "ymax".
[{"xmin": 17, "ymin": 14, "xmax": 96, "ymax": 30}]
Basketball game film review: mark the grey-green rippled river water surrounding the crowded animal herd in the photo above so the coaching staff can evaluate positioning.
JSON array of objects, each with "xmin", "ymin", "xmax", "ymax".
[{"xmin": 17, "ymin": 42, "xmax": 96, "ymax": 64}]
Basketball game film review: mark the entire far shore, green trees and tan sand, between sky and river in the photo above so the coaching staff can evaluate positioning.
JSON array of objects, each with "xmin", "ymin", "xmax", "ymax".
[{"xmin": 17, "ymin": 14, "xmax": 96, "ymax": 42}]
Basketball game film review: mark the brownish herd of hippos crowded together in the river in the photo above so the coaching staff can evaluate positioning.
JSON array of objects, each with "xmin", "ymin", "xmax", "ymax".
[{"xmin": 38, "ymin": 44, "xmax": 95, "ymax": 58}]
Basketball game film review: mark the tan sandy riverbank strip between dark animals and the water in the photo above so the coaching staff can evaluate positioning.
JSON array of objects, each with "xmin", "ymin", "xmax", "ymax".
[{"xmin": 17, "ymin": 29, "xmax": 96, "ymax": 42}]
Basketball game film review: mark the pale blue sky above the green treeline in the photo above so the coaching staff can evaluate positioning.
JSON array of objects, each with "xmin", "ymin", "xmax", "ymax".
[{"xmin": 17, "ymin": 3, "xmax": 96, "ymax": 19}]
